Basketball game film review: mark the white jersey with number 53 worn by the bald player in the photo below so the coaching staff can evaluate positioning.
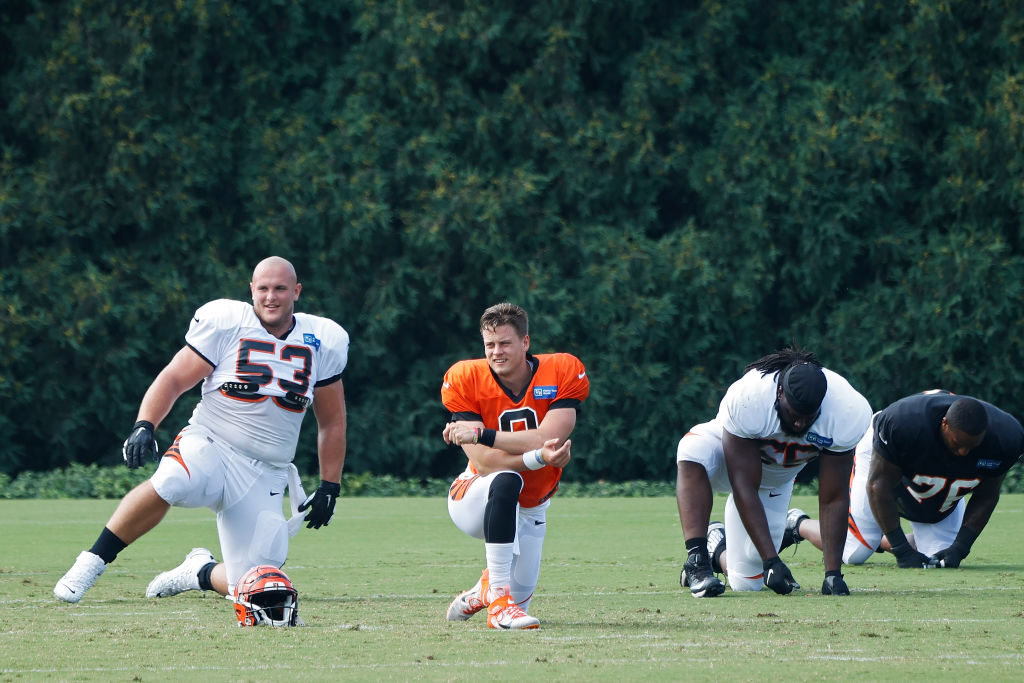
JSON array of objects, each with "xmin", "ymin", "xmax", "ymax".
[{"xmin": 185, "ymin": 299, "xmax": 348, "ymax": 465}]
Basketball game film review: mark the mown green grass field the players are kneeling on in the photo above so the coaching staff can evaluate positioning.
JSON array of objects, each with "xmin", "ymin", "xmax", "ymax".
[{"xmin": 0, "ymin": 496, "xmax": 1024, "ymax": 681}]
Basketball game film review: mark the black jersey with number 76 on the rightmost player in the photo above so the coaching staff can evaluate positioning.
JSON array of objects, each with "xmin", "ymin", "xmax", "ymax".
[{"xmin": 873, "ymin": 391, "xmax": 1024, "ymax": 523}]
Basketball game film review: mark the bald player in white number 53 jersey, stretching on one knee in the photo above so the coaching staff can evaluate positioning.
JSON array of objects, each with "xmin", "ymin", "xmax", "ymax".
[{"xmin": 53, "ymin": 256, "xmax": 348, "ymax": 602}]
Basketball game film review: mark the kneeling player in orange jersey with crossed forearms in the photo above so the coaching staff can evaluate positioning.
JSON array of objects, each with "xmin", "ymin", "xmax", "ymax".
[{"xmin": 441, "ymin": 303, "xmax": 590, "ymax": 629}]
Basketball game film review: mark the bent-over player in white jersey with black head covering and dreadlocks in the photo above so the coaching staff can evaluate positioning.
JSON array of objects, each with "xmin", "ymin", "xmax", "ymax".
[{"xmin": 676, "ymin": 348, "xmax": 871, "ymax": 597}]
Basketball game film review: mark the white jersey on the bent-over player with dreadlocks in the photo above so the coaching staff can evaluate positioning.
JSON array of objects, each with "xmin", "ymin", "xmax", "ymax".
[{"xmin": 713, "ymin": 369, "xmax": 871, "ymax": 488}]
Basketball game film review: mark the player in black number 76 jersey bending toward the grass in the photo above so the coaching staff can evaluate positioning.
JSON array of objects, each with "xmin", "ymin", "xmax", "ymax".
[{"xmin": 783, "ymin": 390, "xmax": 1024, "ymax": 569}]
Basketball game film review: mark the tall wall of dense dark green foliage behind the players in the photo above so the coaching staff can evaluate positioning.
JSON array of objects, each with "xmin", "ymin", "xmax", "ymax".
[{"xmin": 0, "ymin": 0, "xmax": 1024, "ymax": 480}]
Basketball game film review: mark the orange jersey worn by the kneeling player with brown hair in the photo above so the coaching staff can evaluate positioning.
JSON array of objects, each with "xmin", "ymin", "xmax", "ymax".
[{"xmin": 441, "ymin": 353, "xmax": 590, "ymax": 508}]
